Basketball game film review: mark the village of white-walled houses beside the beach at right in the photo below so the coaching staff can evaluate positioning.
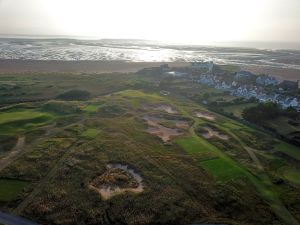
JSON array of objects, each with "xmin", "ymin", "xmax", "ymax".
[{"xmin": 144, "ymin": 61, "xmax": 300, "ymax": 112}]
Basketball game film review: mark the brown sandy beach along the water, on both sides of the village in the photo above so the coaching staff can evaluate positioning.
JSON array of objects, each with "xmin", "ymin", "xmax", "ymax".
[{"xmin": 0, "ymin": 59, "xmax": 300, "ymax": 81}]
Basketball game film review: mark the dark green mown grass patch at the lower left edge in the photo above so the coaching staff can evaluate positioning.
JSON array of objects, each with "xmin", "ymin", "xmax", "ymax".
[{"xmin": 0, "ymin": 179, "xmax": 29, "ymax": 202}]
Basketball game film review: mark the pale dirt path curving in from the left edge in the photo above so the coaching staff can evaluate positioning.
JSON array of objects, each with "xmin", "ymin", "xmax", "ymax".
[{"xmin": 0, "ymin": 136, "xmax": 25, "ymax": 171}]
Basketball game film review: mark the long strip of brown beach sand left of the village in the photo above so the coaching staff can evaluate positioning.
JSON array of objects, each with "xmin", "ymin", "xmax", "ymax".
[{"xmin": 0, "ymin": 60, "xmax": 188, "ymax": 74}]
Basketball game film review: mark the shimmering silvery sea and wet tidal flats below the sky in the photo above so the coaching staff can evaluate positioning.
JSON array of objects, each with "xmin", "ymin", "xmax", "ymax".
[{"xmin": 0, "ymin": 37, "xmax": 300, "ymax": 70}]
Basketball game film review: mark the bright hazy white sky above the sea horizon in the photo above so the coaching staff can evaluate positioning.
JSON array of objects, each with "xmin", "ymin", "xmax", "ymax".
[{"xmin": 0, "ymin": 0, "xmax": 300, "ymax": 44}]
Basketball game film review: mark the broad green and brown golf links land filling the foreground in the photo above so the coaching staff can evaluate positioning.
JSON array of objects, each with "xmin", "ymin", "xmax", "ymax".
[{"xmin": 0, "ymin": 72, "xmax": 300, "ymax": 225}]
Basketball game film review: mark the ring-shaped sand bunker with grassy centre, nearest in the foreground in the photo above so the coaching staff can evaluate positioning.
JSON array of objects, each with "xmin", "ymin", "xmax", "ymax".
[{"xmin": 89, "ymin": 163, "xmax": 144, "ymax": 200}]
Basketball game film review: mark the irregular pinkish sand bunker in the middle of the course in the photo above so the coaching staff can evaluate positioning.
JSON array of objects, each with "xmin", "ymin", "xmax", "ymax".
[{"xmin": 143, "ymin": 116, "xmax": 182, "ymax": 142}]
